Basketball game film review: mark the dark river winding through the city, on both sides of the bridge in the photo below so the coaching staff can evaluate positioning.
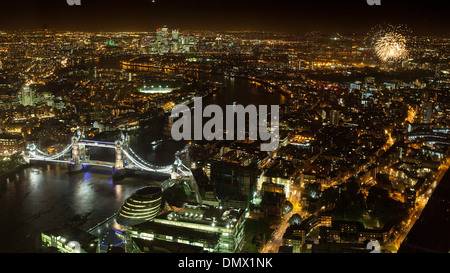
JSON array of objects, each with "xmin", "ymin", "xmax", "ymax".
[{"xmin": 0, "ymin": 56, "xmax": 285, "ymax": 252}]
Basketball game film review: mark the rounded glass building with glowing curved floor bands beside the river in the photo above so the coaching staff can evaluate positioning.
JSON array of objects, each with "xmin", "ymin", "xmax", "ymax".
[{"xmin": 117, "ymin": 187, "xmax": 162, "ymax": 226}]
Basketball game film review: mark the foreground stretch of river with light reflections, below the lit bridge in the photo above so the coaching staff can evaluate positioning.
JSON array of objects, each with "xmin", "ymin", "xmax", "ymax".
[{"xmin": 0, "ymin": 165, "xmax": 164, "ymax": 252}]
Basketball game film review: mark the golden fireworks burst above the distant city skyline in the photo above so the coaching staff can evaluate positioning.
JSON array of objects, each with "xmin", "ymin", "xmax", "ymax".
[{"xmin": 369, "ymin": 25, "xmax": 410, "ymax": 62}]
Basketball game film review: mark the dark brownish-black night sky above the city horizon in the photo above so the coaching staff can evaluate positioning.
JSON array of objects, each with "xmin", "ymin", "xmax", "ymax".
[{"xmin": 0, "ymin": 0, "xmax": 450, "ymax": 35}]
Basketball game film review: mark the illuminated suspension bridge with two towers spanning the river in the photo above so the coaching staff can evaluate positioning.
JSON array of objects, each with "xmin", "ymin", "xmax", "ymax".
[{"xmin": 24, "ymin": 130, "xmax": 202, "ymax": 203}]
